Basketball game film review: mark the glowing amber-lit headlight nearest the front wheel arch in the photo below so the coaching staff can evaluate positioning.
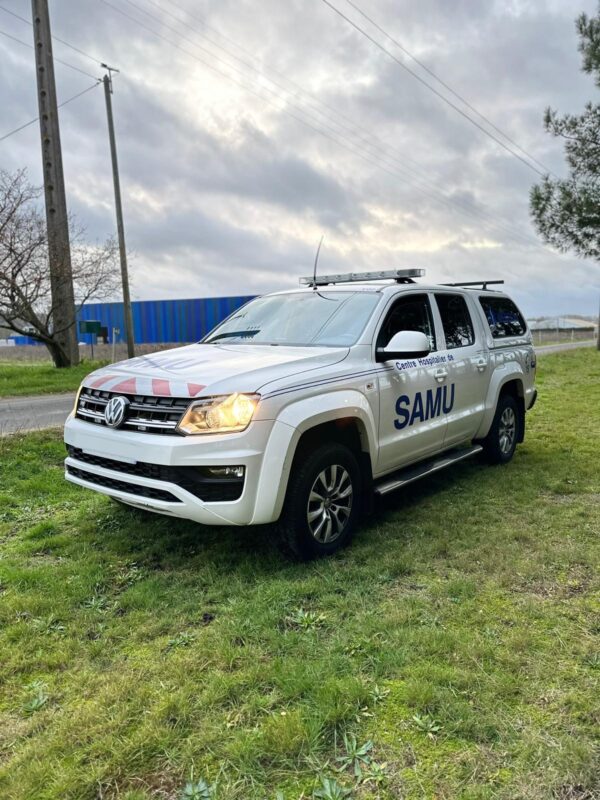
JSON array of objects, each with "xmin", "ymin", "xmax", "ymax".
[{"xmin": 178, "ymin": 392, "xmax": 260, "ymax": 434}]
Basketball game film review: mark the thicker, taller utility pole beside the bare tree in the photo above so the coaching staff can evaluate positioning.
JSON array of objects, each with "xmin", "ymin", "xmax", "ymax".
[{"xmin": 31, "ymin": 0, "xmax": 79, "ymax": 367}]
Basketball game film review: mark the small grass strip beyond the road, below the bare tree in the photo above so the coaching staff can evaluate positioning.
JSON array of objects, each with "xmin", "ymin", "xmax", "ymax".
[{"xmin": 0, "ymin": 361, "xmax": 107, "ymax": 397}]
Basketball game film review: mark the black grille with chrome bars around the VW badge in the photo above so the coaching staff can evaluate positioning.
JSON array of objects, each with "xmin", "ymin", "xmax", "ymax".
[{"xmin": 76, "ymin": 387, "xmax": 191, "ymax": 434}]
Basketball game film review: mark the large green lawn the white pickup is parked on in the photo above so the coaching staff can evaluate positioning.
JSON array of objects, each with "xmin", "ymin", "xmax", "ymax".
[{"xmin": 0, "ymin": 349, "xmax": 600, "ymax": 800}]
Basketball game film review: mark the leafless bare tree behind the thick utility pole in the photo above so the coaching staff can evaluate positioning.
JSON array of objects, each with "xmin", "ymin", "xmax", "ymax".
[{"xmin": 0, "ymin": 170, "xmax": 119, "ymax": 367}]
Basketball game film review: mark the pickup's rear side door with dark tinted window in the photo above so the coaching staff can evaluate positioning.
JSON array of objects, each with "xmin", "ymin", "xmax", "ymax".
[{"xmin": 435, "ymin": 291, "xmax": 490, "ymax": 447}]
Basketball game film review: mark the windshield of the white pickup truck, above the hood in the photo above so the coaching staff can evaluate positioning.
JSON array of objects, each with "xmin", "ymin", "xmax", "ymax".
[{"xmin": 202, "ymin": 291, "xmax": 380, "ymax": 347}]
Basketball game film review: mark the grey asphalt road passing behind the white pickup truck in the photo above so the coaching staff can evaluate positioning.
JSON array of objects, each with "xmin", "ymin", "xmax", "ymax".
[{"xmin": 0, "ymin": 342, "xmax": 594, "ymax": 436}]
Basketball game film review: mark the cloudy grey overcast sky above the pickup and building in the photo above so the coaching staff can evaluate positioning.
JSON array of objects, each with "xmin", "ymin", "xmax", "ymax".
[{"xmin": 0, "ymin": 0, "xmax": 600, "ymax": 316}]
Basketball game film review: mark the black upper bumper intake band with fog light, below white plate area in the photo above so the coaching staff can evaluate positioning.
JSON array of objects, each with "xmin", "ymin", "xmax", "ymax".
[{"xmin": 67, "ymin": 444, "xmax": 244, "ymax": 503}]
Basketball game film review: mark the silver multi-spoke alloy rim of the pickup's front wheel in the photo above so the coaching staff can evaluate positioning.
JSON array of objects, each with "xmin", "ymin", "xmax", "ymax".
[{"xmin": 306, "ymin": 464, "xmax": 354, "ymax": 544}]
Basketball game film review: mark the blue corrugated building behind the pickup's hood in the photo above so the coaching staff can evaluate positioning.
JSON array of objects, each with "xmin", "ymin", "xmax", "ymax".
[{"xmin": 11, "ymin": 295, "xmax": 253, "ymax": 344}]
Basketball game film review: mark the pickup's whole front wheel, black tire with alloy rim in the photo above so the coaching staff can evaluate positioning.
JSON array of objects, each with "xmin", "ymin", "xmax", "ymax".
[{"xmin": 279, "ymin": 442, "xmax": 362, "ymax": 560}]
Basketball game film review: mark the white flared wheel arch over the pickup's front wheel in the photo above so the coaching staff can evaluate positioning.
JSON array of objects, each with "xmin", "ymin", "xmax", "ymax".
[{"xmin": 252, "ymin": 389, "xmax": 377, "ymax": 524}]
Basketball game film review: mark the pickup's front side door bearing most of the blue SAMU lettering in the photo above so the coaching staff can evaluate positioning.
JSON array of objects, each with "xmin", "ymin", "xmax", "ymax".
[{"xmin": 373, "ymin": 292, "xmax": 448, "ymax": 475}]
